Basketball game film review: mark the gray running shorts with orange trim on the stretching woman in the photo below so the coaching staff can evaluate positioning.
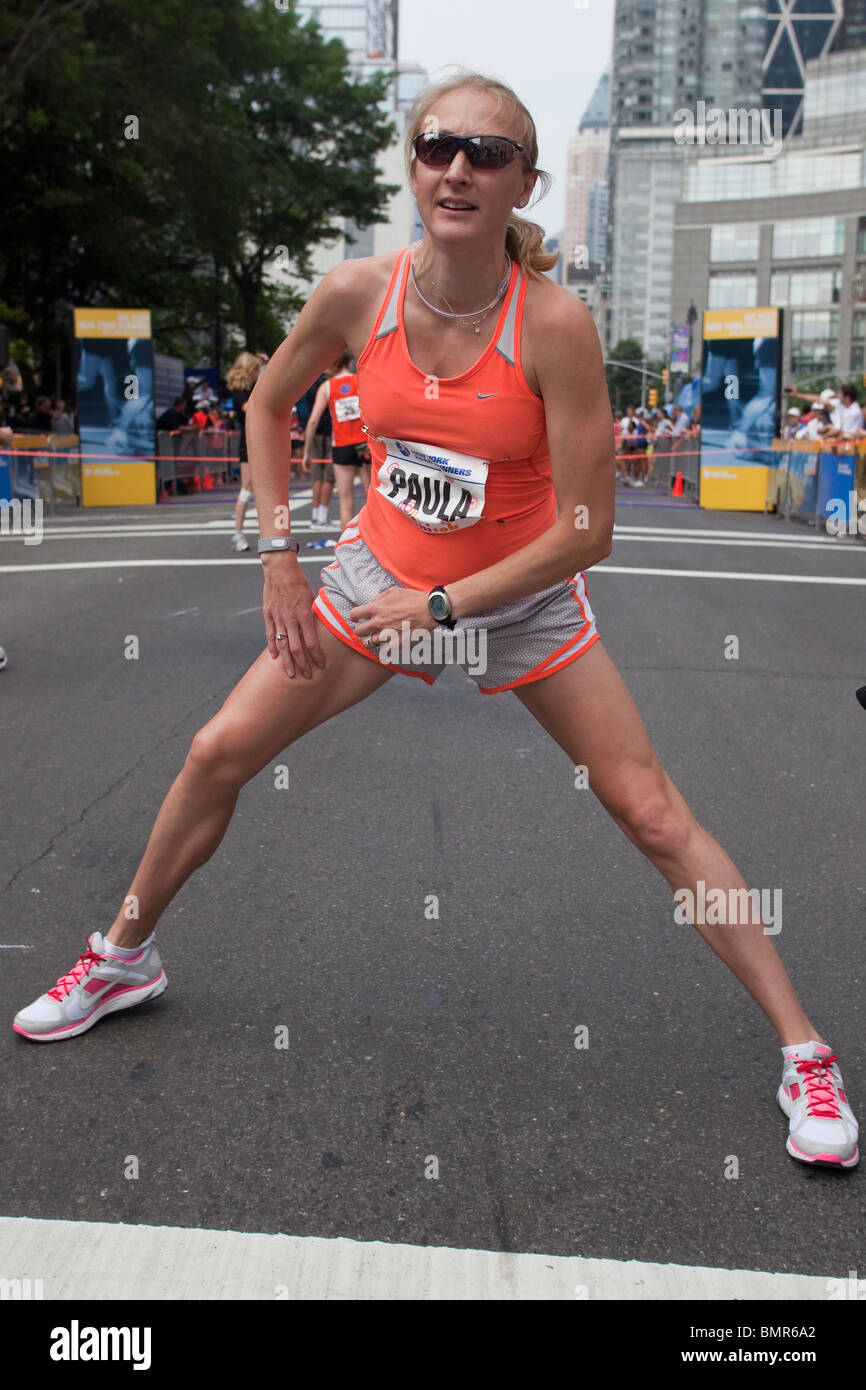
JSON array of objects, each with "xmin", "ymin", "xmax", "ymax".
[{"xmin": 313, "ymin": 517, "xmax": 599, "ymax": 695}]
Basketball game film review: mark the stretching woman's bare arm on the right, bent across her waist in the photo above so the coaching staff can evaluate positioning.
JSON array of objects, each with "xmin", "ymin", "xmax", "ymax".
[{"xmin": 446, "ymin": 295, "xmax": 616, "ymax": 617}]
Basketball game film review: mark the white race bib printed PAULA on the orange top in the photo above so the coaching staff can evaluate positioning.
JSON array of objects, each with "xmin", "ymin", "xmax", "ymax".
[{"xmin": 377, "ymin": 438, "xmax": 489, "ymax": 535}]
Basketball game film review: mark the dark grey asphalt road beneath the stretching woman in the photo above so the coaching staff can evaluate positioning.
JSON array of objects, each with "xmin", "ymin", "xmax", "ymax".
[{"xmin": 0, "ymin": 495, "xmax": 866, "ymax": 1276}]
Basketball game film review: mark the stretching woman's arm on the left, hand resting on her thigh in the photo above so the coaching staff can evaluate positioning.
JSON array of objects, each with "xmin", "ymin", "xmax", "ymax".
[{"xmin": 246, "ymin": 263, "xmax": 357, "ymax": 676}]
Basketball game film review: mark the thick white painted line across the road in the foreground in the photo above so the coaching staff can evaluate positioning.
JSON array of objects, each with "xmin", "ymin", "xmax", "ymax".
[{"xmin": 0, "ymin": 1216, "xmax": 830, "ymax": 1302}]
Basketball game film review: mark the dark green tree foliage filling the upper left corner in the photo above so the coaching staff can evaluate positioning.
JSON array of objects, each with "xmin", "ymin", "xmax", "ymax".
[{"xmin": 0, "ymin": 0, "xmax": 396, "ymax": 393}]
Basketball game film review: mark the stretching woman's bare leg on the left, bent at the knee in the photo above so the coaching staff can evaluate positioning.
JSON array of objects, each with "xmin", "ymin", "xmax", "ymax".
[{"xmin": 107, "ymin": 623, "xmax": 395, "ymax": 947}]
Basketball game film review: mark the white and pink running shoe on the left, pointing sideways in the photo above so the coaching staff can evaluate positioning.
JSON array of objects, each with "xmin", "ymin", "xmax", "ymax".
[{"xmin": 13, "ymin": 931, "xmax": 168, "ymax": 1043}]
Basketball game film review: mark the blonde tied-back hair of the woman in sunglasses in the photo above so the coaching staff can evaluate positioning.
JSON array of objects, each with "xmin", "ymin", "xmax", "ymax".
[{"xmin": 403, "ymin": 68, "xmax": 559, "ymax": 279}]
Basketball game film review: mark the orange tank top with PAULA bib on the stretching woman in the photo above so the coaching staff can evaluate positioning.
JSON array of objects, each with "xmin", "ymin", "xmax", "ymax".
[{"xmin": 358, "ymin": 246, "xmax": 556, "ymax": 589}]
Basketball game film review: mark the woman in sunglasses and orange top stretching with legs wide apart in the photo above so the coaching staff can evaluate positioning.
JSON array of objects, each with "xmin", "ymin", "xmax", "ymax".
[{"xmin": 15, "ymin": 72, "xmax": 858, "ymax": 1169}]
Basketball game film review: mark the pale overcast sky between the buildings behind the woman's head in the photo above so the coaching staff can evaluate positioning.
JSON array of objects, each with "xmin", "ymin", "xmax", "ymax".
[{"xmin": 399, "ymin": 0, "xmax": 614, "ymax": 236}]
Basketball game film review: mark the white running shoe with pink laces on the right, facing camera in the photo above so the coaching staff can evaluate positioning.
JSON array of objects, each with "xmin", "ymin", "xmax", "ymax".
[{"xmin": 777, "ymin": 1038, "xmax": 860, "ymax": 1168}]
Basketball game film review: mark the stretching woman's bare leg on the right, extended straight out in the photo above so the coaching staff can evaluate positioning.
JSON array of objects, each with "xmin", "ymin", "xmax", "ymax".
[{"xmin": 514, "ymin": 641, "xmax": 823, "ymax": 1047}]
